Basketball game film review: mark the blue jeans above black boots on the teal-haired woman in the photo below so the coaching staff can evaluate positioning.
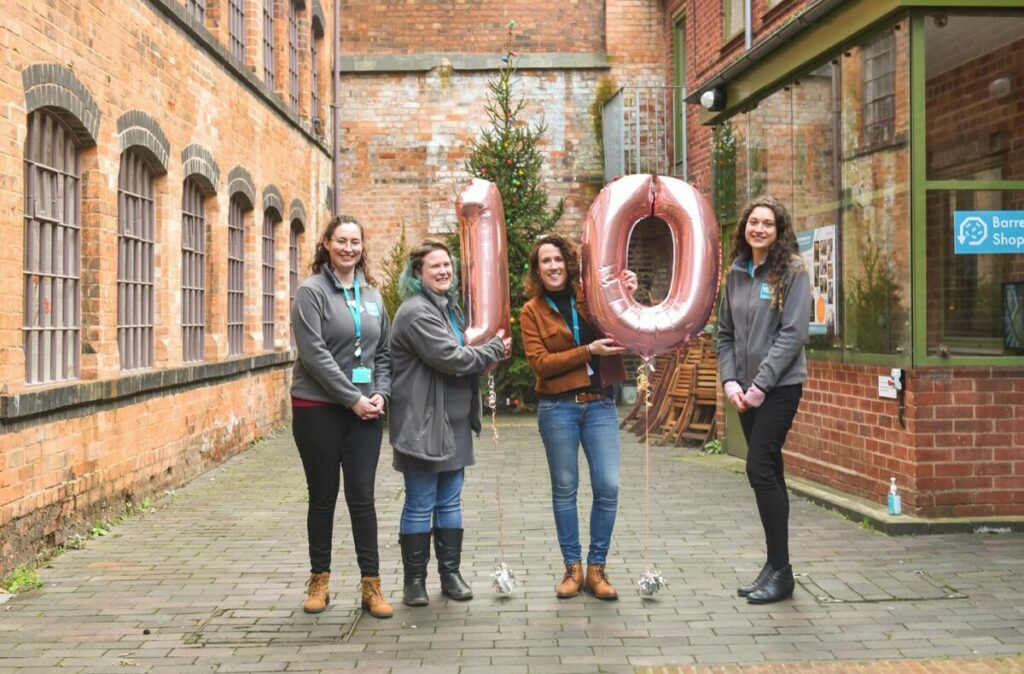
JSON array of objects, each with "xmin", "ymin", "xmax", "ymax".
[{"xmin": 398, "ymin": 468, "xmax": 466, "ymax": 534}]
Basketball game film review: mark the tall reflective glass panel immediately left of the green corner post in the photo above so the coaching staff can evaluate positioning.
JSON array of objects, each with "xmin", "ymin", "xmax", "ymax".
[{"xmin": 838, "ymin": 20, "xmax": 911, "ymax": 354}]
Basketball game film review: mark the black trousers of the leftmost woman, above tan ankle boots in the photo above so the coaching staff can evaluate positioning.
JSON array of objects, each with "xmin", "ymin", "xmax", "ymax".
[{"xmin": 292, "ymin": 405, "xmax": 384, "ymax": 577}]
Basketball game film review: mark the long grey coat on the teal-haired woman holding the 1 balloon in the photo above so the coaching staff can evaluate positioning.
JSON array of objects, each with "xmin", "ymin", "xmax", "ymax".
[{"xmin": 388, "ymin": 290, "xmax": 505, "ymax": 465}]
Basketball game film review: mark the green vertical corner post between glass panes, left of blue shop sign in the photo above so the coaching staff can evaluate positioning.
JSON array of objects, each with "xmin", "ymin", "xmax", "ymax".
[{"xmin": 910, "ymin": 12, "xmax": 928, "ymax": 368}]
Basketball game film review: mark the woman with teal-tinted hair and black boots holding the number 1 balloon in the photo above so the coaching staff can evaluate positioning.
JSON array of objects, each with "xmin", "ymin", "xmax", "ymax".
[{"xmin": 388, "ymin": 240, "xmax": 511, "ymax": 606}]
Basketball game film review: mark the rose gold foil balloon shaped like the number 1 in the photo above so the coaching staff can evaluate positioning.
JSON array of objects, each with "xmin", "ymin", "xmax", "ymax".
[{"xmin": 455, "ymin": 178, "xmax": 512, "ymax": 344}]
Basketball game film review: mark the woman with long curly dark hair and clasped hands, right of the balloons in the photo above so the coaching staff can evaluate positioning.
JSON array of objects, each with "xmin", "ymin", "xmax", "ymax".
[{"xmin": 718, "ymin": 197, "xmax": 811, "ymax": 603}]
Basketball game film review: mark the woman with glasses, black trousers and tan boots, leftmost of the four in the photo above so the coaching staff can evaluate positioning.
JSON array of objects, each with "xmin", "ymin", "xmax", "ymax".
[{"xmin": 291, "ymin": 215, "xmax": 392, "ymax": 618}]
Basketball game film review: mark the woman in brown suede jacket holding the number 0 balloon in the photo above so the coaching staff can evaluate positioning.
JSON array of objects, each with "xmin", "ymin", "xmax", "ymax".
[{"xmin": 519, "ymin": 235, "xmax": 636, "ymax": 599}]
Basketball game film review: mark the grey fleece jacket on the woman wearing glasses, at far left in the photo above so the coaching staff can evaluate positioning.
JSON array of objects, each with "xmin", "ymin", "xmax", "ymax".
[{"xmin": 292, "ymin": 265, "xmax": 391, "ymax": 408}]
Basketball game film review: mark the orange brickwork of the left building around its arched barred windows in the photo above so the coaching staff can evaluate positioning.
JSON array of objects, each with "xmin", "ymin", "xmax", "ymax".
[{"xmin": 0, "ymin": 0, "xmax": 331, "ymax": 572}]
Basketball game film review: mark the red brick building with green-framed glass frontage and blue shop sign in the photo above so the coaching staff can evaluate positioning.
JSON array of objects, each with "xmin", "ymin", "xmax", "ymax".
[{"xmin": 665, "ymin": 0, "xmax": 1024, "ymax": 522}]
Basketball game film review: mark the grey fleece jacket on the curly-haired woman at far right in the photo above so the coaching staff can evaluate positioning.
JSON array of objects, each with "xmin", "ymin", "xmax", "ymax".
[{"xmin": 718, "ymin": 256, "xmax": 811, "ymax": 393}]
